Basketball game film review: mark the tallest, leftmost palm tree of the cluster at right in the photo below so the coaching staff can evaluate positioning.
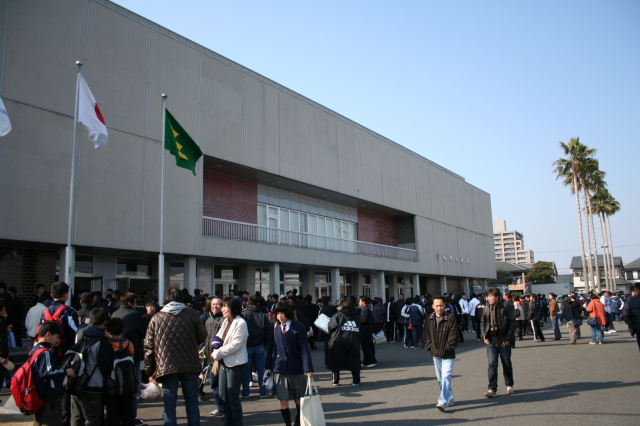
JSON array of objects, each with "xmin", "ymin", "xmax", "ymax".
[{"xmin": 553, "ymin": 138, "xmax": 596, "ymax": 290}]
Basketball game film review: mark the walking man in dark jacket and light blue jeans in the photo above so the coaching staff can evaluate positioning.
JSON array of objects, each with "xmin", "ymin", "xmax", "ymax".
[{"xmin": 424, "ymin": 296, "xmax": 458, "ymax": 411}]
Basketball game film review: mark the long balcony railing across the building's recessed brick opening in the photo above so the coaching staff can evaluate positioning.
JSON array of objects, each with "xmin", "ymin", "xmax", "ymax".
[{"xmin": 202, "ymin": 216, "xmax": 418, "ymax": 262}]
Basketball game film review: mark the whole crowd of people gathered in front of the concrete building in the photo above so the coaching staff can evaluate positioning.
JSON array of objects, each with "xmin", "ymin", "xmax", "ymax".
[{"xmin": 0, "ymin": 282, "xmax": 640, "ymax": 426}]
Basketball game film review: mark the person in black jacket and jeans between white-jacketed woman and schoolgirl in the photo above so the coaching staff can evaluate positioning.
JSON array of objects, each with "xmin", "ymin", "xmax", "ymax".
[{"xmin": 240, "ymin": 296, "xmax": 272, "ymax": 398}]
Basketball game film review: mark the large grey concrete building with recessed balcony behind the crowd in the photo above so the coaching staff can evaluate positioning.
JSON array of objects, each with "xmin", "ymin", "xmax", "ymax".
[{"xmin": 0, "ymin": 0, "xmax": 495, "ymax": 306}]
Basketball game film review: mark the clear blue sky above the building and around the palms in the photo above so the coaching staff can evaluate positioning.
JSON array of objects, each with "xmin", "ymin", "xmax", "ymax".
[{"xmin": 116, "ymin": 0, "xmax": 640, "ymax": 273}]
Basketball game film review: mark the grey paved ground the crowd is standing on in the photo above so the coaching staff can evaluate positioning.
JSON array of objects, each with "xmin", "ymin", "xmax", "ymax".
[{"xmin": 2, "ymin": 323, "xmax": 640, "ymax": 426}]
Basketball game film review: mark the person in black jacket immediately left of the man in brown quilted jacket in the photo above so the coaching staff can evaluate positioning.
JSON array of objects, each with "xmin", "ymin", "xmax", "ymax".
[{"xmin": 111, "ymin": 293, "xmax": 148, "ymax": 424}]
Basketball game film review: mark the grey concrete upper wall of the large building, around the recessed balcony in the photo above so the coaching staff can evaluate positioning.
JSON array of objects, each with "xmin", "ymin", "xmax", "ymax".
[{"xmin": 0, "ymin": 0, "xmax": 495, "ymax": 278}]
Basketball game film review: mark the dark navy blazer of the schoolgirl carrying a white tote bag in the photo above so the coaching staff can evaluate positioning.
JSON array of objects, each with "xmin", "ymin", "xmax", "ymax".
[{"xmin": 264, "ymin": 321, "xmax": 313, "ymax": 374}]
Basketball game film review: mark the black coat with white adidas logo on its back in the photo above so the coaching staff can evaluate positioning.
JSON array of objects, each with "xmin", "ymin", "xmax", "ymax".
[{"xmin": 327, "ymin": 311, "xmax": 360, "ymax": 371}]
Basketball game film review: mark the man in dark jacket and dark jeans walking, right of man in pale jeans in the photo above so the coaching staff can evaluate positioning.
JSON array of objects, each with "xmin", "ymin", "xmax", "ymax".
[{"xmin": 480, "ymin": 287, "xmax": 516, "ymax": 398}]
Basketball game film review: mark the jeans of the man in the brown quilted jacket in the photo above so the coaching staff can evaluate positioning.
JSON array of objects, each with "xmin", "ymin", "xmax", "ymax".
[{"xmin": 161, "ymin": 373, "xmax": 200, "ymax": 426}]
